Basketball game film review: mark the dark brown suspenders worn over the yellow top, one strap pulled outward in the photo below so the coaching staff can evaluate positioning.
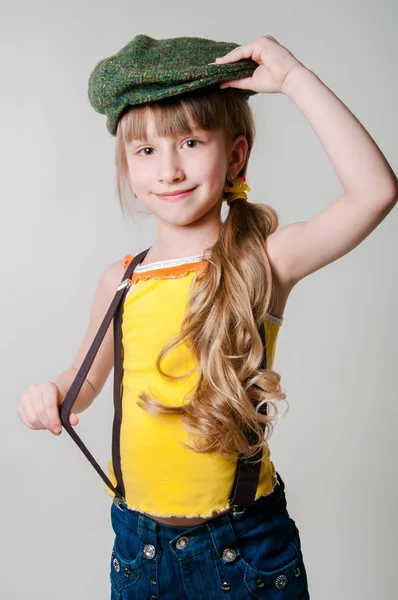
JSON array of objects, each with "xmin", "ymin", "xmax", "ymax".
[{"xmin": 59, "ymin": 248, "xmax": 266, "ymax": 512}]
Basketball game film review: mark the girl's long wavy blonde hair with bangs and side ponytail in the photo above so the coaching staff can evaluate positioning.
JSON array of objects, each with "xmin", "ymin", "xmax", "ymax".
[{"xmin": 115, "ymin": 87, "xmax": 286, "ymax": 459}]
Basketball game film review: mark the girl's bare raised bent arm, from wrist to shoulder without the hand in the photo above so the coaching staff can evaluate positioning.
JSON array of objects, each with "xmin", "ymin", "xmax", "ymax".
[{"xmin": 266, "ymin": 66, "xmax": 398, "ymax": 287}]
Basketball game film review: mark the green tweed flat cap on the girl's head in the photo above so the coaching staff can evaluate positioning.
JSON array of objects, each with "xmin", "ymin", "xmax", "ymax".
[{"xmin": 88, "ymin": 35, "xmax": 258, "ymax": 135}]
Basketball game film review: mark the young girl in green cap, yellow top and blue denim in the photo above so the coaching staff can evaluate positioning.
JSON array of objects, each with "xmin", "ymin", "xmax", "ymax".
[{"xmin": 18, "ymin": 35, "xmax": 398, "ymax": 600}]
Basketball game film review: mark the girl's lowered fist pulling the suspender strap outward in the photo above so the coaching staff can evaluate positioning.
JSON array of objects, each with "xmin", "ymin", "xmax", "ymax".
[{"xmin": 17, "ymin": 381, "xmax": 79, "ymax": 435}]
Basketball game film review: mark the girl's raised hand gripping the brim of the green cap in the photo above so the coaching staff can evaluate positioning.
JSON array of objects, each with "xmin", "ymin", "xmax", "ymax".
[{"xmin": 211, "ymin": 35, "xmax": 305, "ymax": 94}]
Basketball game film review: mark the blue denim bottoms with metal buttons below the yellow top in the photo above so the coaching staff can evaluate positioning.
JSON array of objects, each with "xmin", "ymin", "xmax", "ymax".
[{"xmin": 110, "ymin": 474, "xmax": 310, "ymax": 600}]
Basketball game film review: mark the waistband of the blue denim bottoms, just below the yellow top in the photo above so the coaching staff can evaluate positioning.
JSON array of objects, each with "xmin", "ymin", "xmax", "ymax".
[{"xmin": 111, "ymin": 473, "xmax": 286, "ymax": 554}]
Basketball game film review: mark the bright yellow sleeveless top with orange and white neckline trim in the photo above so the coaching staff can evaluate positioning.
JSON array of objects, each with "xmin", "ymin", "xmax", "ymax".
[{"xmin": 105, "ymin": 255, "xmax": 282, "ymax": 517}]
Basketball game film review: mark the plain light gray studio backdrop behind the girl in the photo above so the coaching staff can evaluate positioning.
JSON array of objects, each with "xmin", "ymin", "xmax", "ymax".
[{"xmin": 0, "ymin": 0, "xmax": 398, "ymax": 600}]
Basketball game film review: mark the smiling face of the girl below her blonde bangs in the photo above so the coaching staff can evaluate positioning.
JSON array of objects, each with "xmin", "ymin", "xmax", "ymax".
[{"xmin": 126, "ymin": 113, "xmax": 246, "ymax": 225}]
